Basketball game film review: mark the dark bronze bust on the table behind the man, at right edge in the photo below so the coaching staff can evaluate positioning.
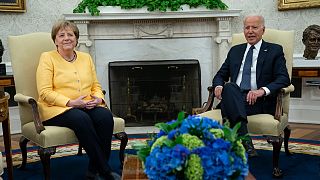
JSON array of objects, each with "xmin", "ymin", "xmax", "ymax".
[{"xmin": 302, "ymin": 24, "xmax": 320, "ymax": 59}]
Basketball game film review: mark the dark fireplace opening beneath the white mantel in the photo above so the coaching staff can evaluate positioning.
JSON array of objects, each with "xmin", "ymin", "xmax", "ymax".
[{"xmin": 108, "ymin": 59, "xmax": 201, "ymax": 126}]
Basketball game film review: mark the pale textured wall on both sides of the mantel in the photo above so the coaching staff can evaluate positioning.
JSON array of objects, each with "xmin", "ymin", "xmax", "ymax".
[{"xmin": 0, "ymin": 0, "xmax": 320, "ymax": 61}]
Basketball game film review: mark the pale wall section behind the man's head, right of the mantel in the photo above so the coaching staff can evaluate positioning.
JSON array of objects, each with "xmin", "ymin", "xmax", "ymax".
[{"xmin": 224, "ymin": 0, "xmax": 320, "ymax": 54}]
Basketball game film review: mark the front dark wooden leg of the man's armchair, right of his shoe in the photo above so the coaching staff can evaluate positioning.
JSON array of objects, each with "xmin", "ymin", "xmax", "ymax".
[{"xmin": 267, "ymin": 136, "xmax": 283, "ymax": 178}]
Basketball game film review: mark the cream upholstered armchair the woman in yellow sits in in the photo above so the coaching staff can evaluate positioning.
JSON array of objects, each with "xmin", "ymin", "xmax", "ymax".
[{"xmin": 8, "ymin": 32, "xmax": 128, "ymax": 179}]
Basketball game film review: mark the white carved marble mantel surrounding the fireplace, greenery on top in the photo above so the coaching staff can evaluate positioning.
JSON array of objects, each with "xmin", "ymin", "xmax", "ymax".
[{"xmin": 64, "ymin": 7, "xmax": 241, "ymax": 107}]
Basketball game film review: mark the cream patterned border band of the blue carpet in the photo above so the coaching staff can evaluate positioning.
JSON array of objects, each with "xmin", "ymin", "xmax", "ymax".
[{"xmin": 4, "ymin": 135, "xmax": 320, "ymax": 166}]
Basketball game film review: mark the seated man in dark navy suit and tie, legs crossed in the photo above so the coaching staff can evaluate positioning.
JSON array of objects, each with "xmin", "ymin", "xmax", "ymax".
[{"xmin": 212, "ymin": 16, "xmax": 290, "ymax": 157}]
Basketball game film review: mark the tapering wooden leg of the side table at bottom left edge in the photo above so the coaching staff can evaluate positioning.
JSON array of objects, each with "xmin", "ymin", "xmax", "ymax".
[{"xmin": 2, "ymin": 116, "xmax": 13, "ymax": 180}]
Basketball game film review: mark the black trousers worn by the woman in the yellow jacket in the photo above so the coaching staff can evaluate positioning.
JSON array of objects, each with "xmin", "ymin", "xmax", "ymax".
[{"xmin": 43, "ymin": 107, "xmax": 114, "ymax": 174}]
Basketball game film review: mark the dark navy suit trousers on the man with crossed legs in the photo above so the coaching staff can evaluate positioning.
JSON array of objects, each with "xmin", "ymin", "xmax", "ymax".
[{"xmin": 220, "ymin": 82, "xmax": 263, "ymax": 131}]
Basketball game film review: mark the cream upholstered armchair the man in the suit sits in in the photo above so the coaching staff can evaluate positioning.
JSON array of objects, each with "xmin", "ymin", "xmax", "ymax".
[{"xmin": 194, "ymin": 29, "xmax": 294, "ymax": 177}]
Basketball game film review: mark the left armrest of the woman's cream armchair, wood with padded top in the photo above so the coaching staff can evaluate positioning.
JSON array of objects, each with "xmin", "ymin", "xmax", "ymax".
[{"xmin": 14, "ymin": 93, "xmax": 45, "ymax": 134}]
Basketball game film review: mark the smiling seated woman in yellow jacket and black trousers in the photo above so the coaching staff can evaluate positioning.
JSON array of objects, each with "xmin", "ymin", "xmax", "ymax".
[{"xmin": 36, "ymin": 21, "xmax": 118, "ymax": 179}]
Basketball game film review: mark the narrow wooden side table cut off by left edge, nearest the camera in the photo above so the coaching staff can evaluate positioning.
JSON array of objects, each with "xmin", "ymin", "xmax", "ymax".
[{"xmin": 0, "ymin": 93, "xmax": 13, "ymax": 180}]
